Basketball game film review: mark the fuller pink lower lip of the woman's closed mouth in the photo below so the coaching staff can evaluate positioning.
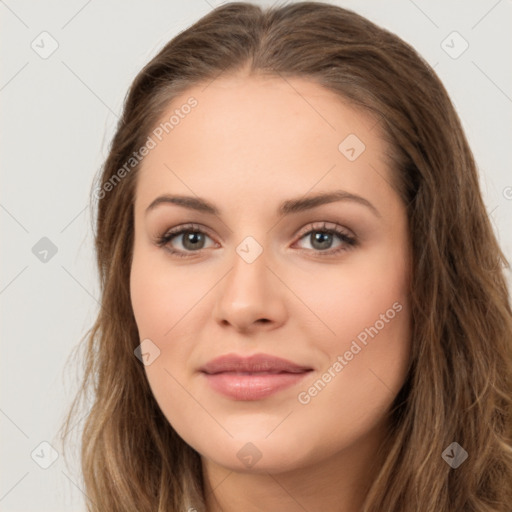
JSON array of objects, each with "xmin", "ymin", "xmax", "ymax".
[{"xmin": 203, "ymin": 371, "xmax": 310, "ymax": 400}]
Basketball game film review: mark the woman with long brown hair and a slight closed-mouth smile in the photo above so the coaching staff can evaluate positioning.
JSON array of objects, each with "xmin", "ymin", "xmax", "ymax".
[{"xmin": 60, "ymin": 2, "xmax": 512, "ymax": 512}]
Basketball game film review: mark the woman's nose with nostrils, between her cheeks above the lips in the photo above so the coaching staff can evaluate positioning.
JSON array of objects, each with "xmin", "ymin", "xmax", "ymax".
[{"xmin": 214, "ymin": 246, "xmax": 287, "ymax": 332}]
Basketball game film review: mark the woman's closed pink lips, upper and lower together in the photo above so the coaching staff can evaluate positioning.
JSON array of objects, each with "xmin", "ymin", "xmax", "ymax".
[{"xmin": 200, "ymin": 354, "xmax": 313, "ymax": 400}]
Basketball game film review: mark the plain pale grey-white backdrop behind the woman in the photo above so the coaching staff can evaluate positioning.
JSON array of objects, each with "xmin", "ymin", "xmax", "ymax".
[{"xmin": 0, "ymin": 0, "xmax": 512, "ymax": 512}]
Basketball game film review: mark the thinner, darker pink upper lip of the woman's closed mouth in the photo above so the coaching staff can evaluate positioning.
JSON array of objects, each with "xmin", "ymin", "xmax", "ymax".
[{"xmin": 200, "ymin": 354, "xmax": 312, "ymax": 374}]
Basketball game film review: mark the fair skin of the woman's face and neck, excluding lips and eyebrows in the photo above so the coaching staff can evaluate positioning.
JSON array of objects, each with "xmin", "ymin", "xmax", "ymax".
[{"xmin": 131, "ymin": 75, "xmax": 411, "ymax": 512}]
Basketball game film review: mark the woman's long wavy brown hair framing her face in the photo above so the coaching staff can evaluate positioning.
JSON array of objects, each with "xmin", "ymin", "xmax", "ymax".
[{"xmin": 62, "ymin": 2, "xmax": 512, "ymax": 512}]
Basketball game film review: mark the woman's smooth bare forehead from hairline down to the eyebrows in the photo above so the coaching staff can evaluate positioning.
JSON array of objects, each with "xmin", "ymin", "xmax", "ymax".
[{"xmin": 137, "ymin": 76, "xmax": 394, "ymax": 214}]
